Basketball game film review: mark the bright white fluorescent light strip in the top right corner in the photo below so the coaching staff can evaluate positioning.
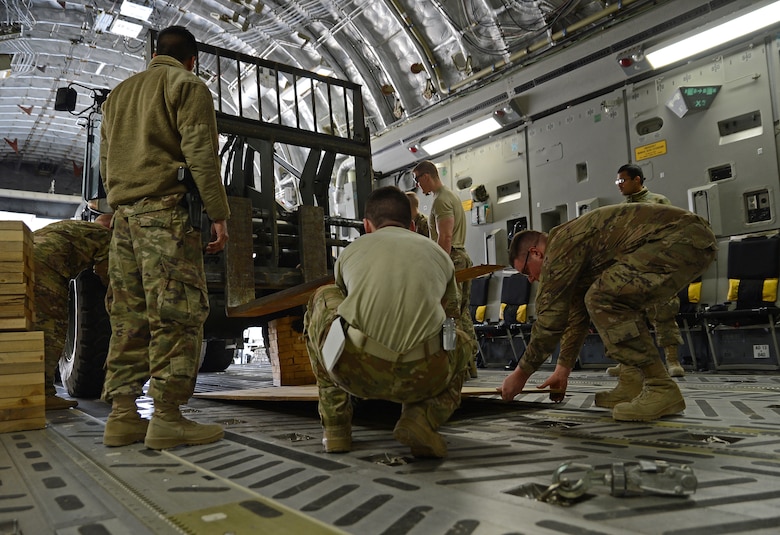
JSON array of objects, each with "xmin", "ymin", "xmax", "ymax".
[{"xmin": 645, "ymin": 1, "xmax": 780, "ymax": 69}]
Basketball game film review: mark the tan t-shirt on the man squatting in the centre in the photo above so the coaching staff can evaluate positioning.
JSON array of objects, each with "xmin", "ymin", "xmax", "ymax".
[{"xmin": 334, "ymin": 227, "xmax": 458, "ymax": 353}]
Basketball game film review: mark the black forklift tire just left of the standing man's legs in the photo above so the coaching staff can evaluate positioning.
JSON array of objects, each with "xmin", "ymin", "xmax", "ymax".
[{"xmin": 59, "ymin": 270, "xmax": 111, "ymax": 399}]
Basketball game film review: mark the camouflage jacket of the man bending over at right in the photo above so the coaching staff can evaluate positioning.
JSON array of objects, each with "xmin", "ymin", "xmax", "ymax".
[{"xmin": 520, "ymin": 203, "xmax": 716, "ymax": 373}]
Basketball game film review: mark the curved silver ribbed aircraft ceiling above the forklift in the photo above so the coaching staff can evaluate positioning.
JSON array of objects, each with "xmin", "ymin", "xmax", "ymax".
[{"xmin": 0, "ymin": 0, "xmax": 664, "ymax": 218}]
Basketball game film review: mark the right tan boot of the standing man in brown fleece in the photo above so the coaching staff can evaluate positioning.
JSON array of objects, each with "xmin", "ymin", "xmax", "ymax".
[{"xmin": 144, "ymin": 400, "xmax": 225, "ymax": 450}]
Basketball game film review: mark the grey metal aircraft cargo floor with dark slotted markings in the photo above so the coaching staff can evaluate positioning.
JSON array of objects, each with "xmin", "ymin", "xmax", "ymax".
[{"xmin": 0, "ymin": 364, "xmax": 780, "ymax": 535}]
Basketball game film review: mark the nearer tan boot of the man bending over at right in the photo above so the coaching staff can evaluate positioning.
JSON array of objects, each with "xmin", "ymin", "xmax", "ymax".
[{"xmin": 612, "ymin": 358, "xmax": 685, "ymax": 422}]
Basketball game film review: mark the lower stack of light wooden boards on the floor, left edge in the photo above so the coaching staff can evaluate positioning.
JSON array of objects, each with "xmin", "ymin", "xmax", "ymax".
[{"xmin": 0, "ymin": 331, "xmax": 46, "ymax": 433}]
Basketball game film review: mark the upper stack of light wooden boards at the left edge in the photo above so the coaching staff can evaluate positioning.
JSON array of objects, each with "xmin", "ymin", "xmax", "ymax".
[{"xmin": 0, "ymin": 221, "xmax": 35, "ymax": 331}]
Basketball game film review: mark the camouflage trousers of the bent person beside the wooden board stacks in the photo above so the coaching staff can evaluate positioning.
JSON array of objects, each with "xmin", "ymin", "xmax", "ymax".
[{"xmin": 34, "ymin": 272, "xmax": 70, "ymax": 396}]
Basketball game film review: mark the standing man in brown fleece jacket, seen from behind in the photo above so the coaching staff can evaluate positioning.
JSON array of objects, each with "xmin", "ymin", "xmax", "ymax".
[{"xmin": 100, "ymin": 26, "xmax": 230, "ymax": 449}]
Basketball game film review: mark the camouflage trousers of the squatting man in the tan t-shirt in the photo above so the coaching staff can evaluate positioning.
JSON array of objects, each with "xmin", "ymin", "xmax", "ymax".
[{"xmin": 304, "ymin": 284, "xmax": 470, "ymax": 429}]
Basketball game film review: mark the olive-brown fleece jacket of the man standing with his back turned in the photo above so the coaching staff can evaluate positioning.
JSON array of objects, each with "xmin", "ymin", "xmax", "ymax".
[{"xmin": 100, "ymin": 55, "xmax": 230, "ymax": 220}]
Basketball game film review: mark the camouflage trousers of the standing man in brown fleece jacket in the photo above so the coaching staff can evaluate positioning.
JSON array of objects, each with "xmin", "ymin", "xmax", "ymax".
[{"xmin": 103, "ymin": 195, "xmax": 209, "ymax": 405}]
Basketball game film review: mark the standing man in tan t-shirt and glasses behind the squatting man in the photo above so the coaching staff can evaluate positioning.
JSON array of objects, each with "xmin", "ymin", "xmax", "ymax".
[{"xmin": 413, "ymin": 160, "xmax": 477, "ymax": 378}]
